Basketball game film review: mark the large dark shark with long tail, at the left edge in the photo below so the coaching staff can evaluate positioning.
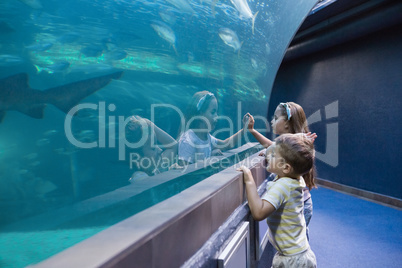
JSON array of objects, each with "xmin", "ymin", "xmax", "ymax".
[{"xmin": 0, "ymin": 71, "xmax": 123, "ymax": 123}]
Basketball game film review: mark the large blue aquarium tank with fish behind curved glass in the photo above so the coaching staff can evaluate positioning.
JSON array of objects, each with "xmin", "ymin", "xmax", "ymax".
[{"xmin": 0, "ymin": 0, "xmax": 317, "ymax": 267}]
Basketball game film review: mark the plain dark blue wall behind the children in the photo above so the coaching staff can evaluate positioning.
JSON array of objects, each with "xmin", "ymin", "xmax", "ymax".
[{"xmin": 268, "ymin": 25, "xmax": 402, "ymax": 198}]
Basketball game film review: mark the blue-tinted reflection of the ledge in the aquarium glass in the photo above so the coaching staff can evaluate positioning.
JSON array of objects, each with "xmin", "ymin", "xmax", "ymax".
[{"xmin": 2, "ymin": 143, "xmax": 262, "ymax": 266}]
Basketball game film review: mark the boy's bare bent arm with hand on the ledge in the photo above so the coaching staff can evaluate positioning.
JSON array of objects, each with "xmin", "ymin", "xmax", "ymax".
[{"xmin": 238, "ymin": 166, "xmax": 275, "ymax": 221}]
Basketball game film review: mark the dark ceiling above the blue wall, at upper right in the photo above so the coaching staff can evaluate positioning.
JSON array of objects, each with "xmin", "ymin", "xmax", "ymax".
[{"xmin": 284, "ymin": 0, "xmax": 402, "ymax": 61}]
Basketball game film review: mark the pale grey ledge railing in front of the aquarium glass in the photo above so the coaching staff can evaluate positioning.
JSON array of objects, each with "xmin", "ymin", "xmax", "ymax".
[{"xmin": 29, "ymin": 144, "xmax": 266, "ymax": 267}]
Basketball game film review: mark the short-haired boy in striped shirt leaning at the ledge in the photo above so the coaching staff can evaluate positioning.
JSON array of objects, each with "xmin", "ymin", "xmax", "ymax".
[{"xmin": 238, "ymin": 134, "xmax": 317, "ymax": 268}]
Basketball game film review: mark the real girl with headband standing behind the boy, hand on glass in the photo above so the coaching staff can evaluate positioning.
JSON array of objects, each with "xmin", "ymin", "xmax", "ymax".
[{"xmin": 246, "ymin": 102, "xmax": 317, "ymax": 237}]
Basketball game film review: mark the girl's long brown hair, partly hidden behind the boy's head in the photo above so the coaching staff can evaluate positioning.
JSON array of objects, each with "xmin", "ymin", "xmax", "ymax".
[{"xmin": 277, "ymin": 102, "xmax": 317, "ymax": 190}]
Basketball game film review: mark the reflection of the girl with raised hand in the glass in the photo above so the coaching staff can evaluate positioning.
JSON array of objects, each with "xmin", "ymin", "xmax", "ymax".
[{"xmin": 178, "ymin": 91, "xmax": 246, "ymax": 164}]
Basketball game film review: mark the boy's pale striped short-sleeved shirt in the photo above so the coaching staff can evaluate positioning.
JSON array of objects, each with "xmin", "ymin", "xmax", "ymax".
[{"xmin": 262, "ymin": 177, "xmax": 309, "ymax": 255}]
